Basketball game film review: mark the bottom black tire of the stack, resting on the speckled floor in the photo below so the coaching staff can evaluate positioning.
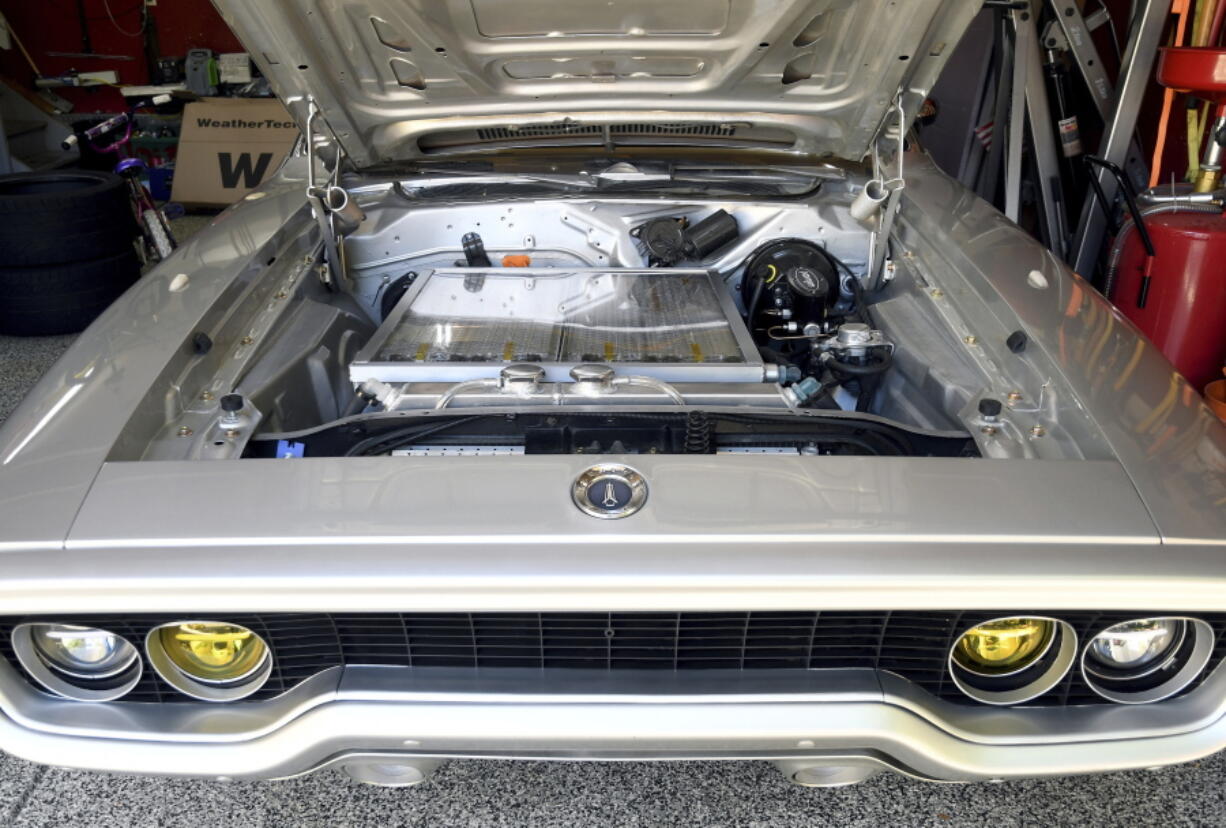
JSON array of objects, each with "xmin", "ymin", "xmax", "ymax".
[{"xmin": 0, "ymin": 244, "xmax": 141, "ymax": 336}]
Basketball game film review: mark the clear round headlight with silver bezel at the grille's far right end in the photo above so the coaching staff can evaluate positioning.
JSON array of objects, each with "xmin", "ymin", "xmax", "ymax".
[{"xmin": 1081, "ymin": 617, "xmax": 1214, "ymax": 704}]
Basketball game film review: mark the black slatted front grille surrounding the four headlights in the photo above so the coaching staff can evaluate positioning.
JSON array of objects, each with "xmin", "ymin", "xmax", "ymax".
[{"xmin": 0, "ymin": 610, "xmax": 1226, "ymax": 707}]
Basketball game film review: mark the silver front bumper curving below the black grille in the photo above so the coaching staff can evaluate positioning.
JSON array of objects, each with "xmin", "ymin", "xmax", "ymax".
[{"xmin": 0, "ymin": 665, "xmax": 1226, "ymax": 781}]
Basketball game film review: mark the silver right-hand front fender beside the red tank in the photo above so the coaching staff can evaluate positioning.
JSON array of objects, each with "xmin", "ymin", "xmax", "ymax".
[{"xmin": 899, "ymin": 157, "xmax": 1226, "ymax": 550}]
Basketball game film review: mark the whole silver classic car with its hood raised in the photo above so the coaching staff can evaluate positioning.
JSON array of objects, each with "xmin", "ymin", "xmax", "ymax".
[{"xmin": 0, "ymin": 0, "xmax": 1226, "ymax": 785}]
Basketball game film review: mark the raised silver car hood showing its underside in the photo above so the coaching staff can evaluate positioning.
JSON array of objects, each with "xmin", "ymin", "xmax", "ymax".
[{"xmin": 213, "ymin": 0, "xmax": 982, "ymax": 167}]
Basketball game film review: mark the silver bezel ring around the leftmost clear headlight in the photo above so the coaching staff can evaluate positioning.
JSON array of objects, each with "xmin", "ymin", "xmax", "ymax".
[{"xmin": 11, "ymin": 621, "xmax": 145, "ymax": 702}]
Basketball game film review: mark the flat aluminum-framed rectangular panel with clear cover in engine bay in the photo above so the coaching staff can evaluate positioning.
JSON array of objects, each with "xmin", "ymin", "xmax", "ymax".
[{"xmin": 349, "ymin": 267, "xmax": 765, "ymax": 383}]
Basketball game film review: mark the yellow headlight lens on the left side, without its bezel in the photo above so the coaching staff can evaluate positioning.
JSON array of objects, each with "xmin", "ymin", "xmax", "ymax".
[{"xmin": 158, "ymin": 621, "xmax": 268, "ymax": 684}]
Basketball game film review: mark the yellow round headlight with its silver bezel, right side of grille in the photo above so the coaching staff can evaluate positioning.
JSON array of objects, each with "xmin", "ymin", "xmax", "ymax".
[{"xmin": 949, "ymin": 616, "xmax": 1078, "ymax": 704}]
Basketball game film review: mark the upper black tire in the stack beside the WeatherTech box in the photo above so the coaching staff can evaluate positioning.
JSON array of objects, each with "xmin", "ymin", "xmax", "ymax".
[{"xmin": 0, "ymin": 169, "xmax": 137, "ymax": 266}]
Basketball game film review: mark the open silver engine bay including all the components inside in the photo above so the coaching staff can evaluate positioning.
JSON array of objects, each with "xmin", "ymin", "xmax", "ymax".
[{"xmin": 113, "ymin": 182, "xmax": 1069, "ymax": 459}]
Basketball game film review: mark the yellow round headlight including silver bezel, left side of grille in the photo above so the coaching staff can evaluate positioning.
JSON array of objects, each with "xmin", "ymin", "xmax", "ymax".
[{"xmin": 146, "ymin": 621, "xmax": 272, "ymax": 702}]
